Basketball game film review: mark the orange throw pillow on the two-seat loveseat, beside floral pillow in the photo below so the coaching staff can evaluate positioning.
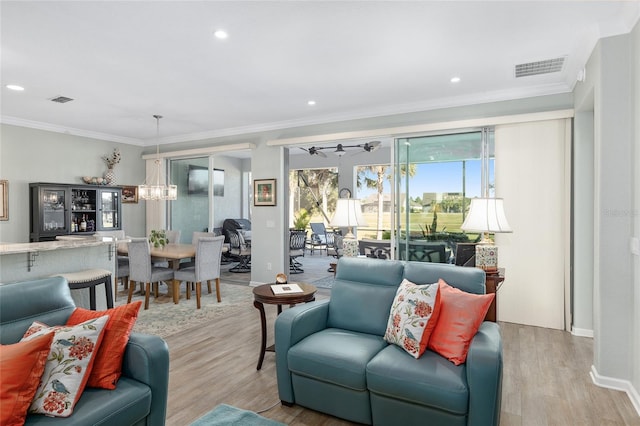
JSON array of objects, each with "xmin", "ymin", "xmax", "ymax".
[{"xmin": 428, "ymin": 279, "xmax": 495, "ymax": 365}]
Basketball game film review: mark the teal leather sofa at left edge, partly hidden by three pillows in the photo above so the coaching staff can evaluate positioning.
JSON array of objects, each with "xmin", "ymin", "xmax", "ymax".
[{"xmin": 0, "ymin": 277, "xmax": 169, "ymax": 426}]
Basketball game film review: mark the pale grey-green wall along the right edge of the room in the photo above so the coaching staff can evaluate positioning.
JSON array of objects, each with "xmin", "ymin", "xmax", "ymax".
[{"xmin": 574, "ymin": 20, "xmax": 640, "ymax": 407}]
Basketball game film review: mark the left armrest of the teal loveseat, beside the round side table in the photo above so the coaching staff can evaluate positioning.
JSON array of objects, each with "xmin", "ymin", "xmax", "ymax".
[{"xmin": 275, "ymin": 299, "xmax": 329, "ymax": 403}]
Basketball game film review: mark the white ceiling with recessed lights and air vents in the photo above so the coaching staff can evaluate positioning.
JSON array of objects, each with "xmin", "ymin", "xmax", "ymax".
[{"xmin": 0, "ymin": 0, "xmax": 640, "ymax": 145}]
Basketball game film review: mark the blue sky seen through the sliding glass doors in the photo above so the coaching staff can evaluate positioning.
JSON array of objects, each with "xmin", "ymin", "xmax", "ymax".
[{"xmin": 358, "ymin": 160, "xmax": 493, "ymax": 199}]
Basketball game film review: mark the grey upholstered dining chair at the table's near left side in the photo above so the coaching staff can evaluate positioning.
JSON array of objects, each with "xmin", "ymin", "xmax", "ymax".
[{"xmin": 127, "ymin": 238, "xmax": 174, "ymax": 309}]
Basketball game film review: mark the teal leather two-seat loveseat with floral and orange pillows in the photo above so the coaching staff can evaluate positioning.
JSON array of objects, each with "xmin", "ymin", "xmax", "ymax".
[{"xmin": 275, "ymin": 257, "xmax": 502, "ymax": 426}]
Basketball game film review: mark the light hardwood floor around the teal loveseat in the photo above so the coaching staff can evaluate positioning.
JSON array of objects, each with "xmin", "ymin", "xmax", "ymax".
[{"xmin": 166, "ymin": 256, "xmax": 640, "ymax": 426}]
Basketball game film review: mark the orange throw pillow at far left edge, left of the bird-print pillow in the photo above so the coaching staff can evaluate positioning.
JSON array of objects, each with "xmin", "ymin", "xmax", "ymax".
[{"xmin": 0, "ymin": 333, "xmax": 55, "ymax": 426}]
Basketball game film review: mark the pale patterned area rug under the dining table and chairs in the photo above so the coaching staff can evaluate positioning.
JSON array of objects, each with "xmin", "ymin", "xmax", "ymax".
[{"xmin": 115, "ymin": 282, "xmax": 253, "ymax": 338}]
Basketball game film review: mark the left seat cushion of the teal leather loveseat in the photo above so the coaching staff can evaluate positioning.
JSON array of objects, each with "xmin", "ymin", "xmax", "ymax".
[{"xmin": 287, "ymin": 328, "xmax": 387, "ymax": 391}]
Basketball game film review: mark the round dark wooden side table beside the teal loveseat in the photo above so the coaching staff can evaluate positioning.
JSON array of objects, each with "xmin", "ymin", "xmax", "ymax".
[{"xmin": 253, "ymin": 283, "xmax": 317, "ymax": 370}]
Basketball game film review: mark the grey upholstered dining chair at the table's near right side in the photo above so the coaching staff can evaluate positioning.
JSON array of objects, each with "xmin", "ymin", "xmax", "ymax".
[{"xmin": 173, "ymin": 237, "xmax": 224, "ymax": 309}]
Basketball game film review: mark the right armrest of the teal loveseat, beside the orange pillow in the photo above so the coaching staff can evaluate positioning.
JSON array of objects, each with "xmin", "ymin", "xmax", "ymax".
[{"xmin": 466, "ymin": 321, "xmax": 502, "ymax": 425}]
